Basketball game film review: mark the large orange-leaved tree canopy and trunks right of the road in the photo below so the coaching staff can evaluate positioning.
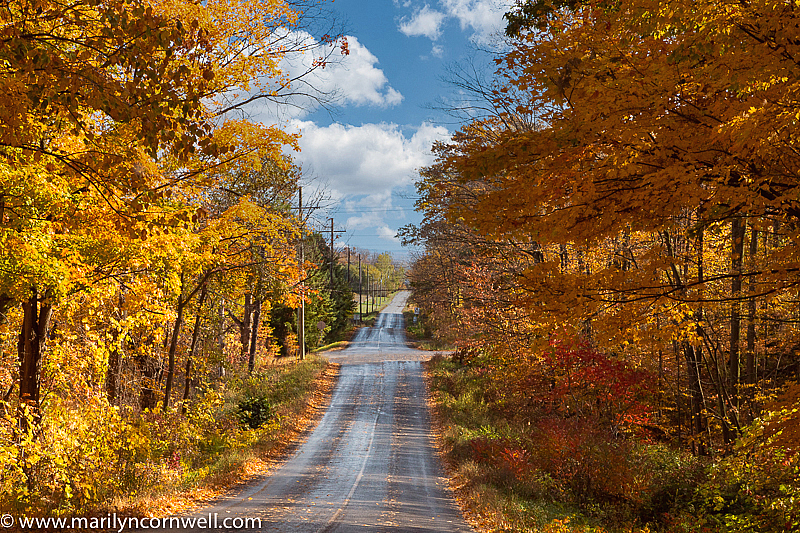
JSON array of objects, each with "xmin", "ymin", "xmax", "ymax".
[{"xmin": 412, "ymin": 0, "xmax": 800, "ymax": 453}]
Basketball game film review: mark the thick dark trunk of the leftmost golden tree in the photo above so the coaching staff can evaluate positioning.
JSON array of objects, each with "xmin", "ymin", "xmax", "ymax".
[{"xmin": 17, "ymin": 289, "xmax": 53, "ymax": 431}]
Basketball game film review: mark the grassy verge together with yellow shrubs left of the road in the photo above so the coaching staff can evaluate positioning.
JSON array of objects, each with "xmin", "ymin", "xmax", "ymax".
[{"xmin": 0, "ymin": 355, "xmax": 338, "ymax": 517}]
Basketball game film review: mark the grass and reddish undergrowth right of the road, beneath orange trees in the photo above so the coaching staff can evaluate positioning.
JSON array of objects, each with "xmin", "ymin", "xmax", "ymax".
[{"xmin": 428, "ymin": 355, "xmax": 800, "ymax": 533}]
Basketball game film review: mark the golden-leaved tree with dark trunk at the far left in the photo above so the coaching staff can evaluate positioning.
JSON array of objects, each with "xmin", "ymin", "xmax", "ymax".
[{"xmin": 0, "ymin": 2, "xmax": 219, "ymax": 424}]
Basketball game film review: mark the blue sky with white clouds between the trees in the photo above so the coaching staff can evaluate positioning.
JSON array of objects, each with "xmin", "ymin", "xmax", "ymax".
[{"xmin": 248, "ymin": 0, "xmax": 511, "ymax": 258}]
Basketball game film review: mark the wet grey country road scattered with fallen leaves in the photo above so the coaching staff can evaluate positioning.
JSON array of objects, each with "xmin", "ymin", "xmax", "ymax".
[{"xmin": 173, "ymin": 292, "xmax": 472, "ymax": 533}]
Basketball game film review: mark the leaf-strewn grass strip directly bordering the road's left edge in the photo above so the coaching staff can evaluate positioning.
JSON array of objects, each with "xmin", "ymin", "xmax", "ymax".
[{"xmin": 130, "ymin": 354, "xmax": 338, "ymax": 516}]
